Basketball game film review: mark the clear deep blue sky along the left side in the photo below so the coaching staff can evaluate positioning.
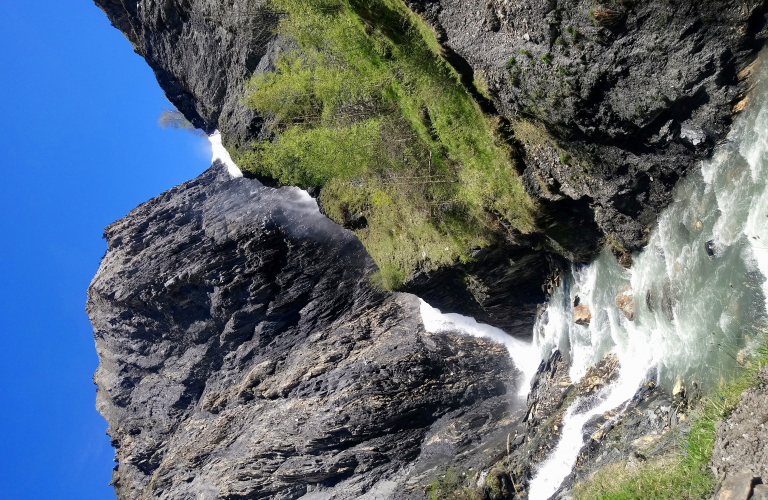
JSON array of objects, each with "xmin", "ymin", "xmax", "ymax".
[{"xmin": 0, "ymin": 0, "xmax": 211, "ymax": 500}]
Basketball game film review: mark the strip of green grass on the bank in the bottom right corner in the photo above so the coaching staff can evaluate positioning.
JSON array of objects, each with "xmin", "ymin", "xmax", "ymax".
[{"xmin": 574, "ymin": 335, "xmax": 768, "ymax": 500}]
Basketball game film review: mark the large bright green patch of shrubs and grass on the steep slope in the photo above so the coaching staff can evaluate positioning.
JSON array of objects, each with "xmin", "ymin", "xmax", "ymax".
[{"xmin": 235, "ymin": 0, "xmax": 536, "ymax": 289}]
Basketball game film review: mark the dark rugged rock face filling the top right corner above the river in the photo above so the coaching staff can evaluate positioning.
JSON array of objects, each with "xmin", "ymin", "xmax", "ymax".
[{"xmin": 406, "ymin": 0, "xmax": 766, "ymax": 251}]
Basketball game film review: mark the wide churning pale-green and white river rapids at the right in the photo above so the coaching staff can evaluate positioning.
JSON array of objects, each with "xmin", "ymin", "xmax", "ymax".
[{"xmin": 529, "ymin": 55, "xmax": 768, "ymax": 500}]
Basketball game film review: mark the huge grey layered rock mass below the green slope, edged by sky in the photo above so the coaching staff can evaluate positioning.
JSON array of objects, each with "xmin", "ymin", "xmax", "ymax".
[{"xmin": 87, "ymin": 163, "xmax": 516, "ymax": 500}]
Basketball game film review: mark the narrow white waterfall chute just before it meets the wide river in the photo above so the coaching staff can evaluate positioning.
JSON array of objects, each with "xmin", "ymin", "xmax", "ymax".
[{"xmin": 419, "ymin": 299, "xmax": 541, "ymax": 396}]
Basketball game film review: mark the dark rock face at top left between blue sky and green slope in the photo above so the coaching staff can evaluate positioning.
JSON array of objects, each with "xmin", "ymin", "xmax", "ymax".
[{"xmin": 95, "ymin": 0, "xmax": 280, "ymax": 147}]
